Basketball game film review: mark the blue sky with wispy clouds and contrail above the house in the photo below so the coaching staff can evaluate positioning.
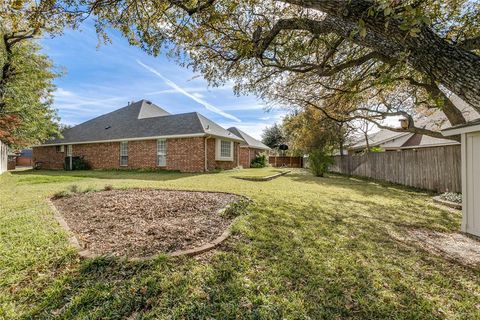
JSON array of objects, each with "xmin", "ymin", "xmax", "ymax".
[{"xmin": 41, "ymin": 24, "xmax": 285, "ymax": 138}]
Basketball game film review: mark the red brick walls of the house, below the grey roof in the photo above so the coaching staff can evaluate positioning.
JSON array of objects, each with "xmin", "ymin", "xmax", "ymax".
[{"xmin": 33, "ymin": 137, "xmax": 239, "ymax": 172}]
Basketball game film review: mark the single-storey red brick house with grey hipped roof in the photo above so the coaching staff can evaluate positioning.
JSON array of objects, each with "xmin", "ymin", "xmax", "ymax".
[{"xmin": 33, "ymin": 100, "xmax": 245, "ymax": 172}]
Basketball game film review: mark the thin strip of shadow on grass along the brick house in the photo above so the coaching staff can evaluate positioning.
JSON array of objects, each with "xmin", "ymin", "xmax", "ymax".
[{"xmin": 11, "ymin": 170, "xmax": 203, "ymax": 184}]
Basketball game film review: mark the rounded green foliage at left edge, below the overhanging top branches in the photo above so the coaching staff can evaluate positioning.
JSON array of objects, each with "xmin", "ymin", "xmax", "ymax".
[{"xmin": 0, "ymin": 37, "xmax": 58, "ymax": 147}]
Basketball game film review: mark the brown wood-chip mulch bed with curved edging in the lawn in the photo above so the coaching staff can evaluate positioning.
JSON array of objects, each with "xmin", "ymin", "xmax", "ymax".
[{"xmin": 52, "ymin": 189, "xmax": 240, "ymax": 257}]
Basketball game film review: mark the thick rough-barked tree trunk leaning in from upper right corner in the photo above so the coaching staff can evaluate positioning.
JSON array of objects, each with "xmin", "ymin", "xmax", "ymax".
[{"xmin": 280, "ymin": 0, "xmax": 480, "ymax": 112}]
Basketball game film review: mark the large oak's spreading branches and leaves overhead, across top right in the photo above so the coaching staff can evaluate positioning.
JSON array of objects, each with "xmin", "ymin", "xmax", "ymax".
[{"xmin": 72, "ymin": 0, "xmax": 480, "ymax": 135}]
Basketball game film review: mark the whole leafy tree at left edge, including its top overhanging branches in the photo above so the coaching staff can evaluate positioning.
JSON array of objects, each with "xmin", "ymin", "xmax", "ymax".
[{"xmin": 0, "ymin": 0, "xmax": 80, "ymax": 147}]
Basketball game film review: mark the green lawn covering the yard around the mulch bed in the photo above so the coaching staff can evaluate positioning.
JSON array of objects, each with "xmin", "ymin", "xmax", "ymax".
[{"xmin": 0, "ymin": 169, "xmax": 480, "ymax": 319}]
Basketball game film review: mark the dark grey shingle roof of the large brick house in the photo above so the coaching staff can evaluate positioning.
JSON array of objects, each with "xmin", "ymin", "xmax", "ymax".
[{"xmin": 40, "ymin": 100, "xmax": 241, "ymax": 145}]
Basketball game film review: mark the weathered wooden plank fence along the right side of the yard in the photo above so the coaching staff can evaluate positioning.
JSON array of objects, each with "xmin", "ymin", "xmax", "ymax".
[{"xmin": 330, "ymin": 145, "xmax": 462, "ymax": 192}]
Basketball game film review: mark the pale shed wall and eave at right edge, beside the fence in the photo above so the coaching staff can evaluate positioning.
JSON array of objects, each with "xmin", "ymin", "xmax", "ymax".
[{"xmin": 442, "ymin": 119, "xmax": 480, "ymax": 237}]
